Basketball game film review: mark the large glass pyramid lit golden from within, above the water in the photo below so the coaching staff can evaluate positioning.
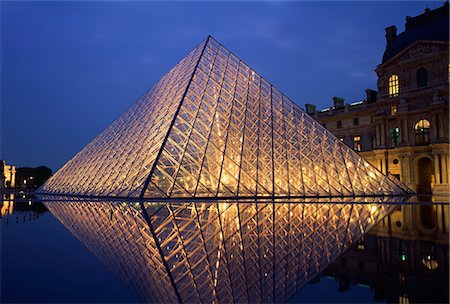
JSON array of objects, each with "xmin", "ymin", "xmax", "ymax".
[{"xmin": 39, "ymin": 37, "xmax": 407, "ymax": 197}]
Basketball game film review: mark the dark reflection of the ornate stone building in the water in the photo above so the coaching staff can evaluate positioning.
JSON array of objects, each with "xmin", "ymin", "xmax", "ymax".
[{"xmin": 324, "ymin": 204, "xmax": 449, "ymax": 303}]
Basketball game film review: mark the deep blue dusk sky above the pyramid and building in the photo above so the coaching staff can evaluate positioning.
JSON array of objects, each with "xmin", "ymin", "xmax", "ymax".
[{"xmin": 0, "ymin": 1, "xmax": 434, "ymax": 171}]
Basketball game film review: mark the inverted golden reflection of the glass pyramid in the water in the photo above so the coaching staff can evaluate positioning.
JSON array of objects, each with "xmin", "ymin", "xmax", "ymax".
[{"xmin": 39, "ymin": 198, "xmax": 393, "ymax": 303}]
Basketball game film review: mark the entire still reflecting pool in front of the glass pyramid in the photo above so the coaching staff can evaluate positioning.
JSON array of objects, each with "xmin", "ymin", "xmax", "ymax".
[{"xmin": 1, "ymin": 197, "xmax": 449, "ymax": 303}]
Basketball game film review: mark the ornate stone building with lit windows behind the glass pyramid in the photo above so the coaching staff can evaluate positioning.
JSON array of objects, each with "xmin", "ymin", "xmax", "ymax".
[{"xmin": 312, "ymin": 2, "xmax": 449, "ymax": 195}]
